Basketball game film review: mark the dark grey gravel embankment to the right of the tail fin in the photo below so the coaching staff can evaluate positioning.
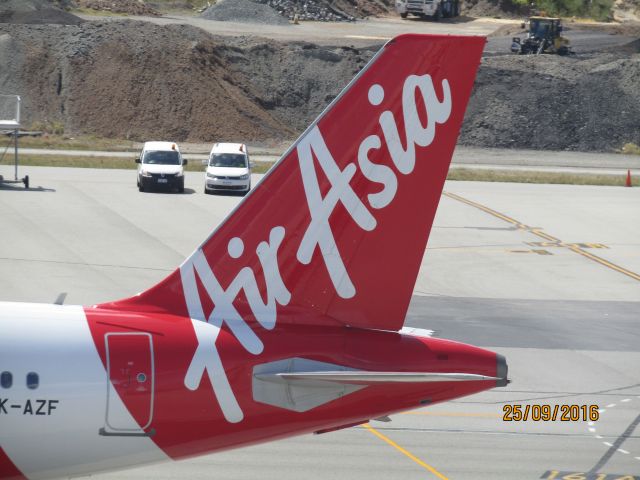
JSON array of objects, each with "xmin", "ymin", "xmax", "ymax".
[{"xmin": 460, "ymin": 52, "xmax": 640, "ymax": 151}]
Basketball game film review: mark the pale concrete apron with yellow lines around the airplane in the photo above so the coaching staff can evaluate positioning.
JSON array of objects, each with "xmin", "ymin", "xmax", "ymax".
[{"xmin": 0, "ymin": 166, "xmax": 640, "ymax": 480}]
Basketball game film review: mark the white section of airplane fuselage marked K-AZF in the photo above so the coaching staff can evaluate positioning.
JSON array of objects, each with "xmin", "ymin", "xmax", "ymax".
[{"xmin": 0, "ymin": 302, "xmax": 168, "ymax": 479}]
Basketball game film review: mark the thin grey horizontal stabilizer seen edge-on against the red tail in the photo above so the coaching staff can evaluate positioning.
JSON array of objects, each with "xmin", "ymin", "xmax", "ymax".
[{"xmin": 255, "ymin": 370, "xmax": 499, "ymax": 384}]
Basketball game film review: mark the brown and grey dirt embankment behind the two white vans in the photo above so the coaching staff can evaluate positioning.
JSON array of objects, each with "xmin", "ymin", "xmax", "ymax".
[{"xmin": 0, "ymin": 20, "xmax": 370, "ymax": 141}]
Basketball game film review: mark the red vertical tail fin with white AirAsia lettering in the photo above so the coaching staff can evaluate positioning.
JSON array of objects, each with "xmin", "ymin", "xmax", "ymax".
[{"xmin": 100, "ymin": 35, "xmax": 485, "ymax": 330}]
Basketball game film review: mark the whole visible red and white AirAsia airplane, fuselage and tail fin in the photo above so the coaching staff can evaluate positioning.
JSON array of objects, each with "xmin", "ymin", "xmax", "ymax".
[{"xmin": 0, "ymin": 35, "xmax": 496, "ymax": 480}]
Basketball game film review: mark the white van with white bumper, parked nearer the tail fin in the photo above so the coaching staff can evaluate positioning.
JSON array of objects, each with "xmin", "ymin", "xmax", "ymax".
[{"xmin": 202, "ymin": 143, "xmax": 251, "ymax": 194}]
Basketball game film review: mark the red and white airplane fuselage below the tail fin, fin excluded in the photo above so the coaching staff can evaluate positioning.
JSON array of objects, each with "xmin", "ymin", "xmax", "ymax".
[{"xmin": 0, "ymin": 303, "xmax": 504, "ymax": 478}]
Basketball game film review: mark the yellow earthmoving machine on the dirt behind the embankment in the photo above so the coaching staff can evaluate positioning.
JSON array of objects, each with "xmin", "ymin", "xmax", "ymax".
[{"xmin": 511, "ymin": 17, "xmax": 571, "ymax": 55}]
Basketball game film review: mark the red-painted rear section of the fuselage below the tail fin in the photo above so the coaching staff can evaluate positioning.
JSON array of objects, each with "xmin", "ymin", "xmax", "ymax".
[{"xmin": 85, "ymin": 308, "xmax": 496, "ymax": 459}]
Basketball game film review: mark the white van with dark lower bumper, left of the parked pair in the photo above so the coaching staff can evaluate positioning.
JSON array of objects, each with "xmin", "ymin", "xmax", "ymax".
[{"xmin": 136, "ymin": 142, "xmax": 187, "ymax": 193}]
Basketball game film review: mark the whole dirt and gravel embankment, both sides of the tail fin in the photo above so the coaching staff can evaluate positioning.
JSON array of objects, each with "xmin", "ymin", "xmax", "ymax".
[{"xmin": 0, "ymin": 20, "xmax": 640, "ymax": 151}]
